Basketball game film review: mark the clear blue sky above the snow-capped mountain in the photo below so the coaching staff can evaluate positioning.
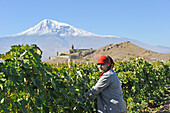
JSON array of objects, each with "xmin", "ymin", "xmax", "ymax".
[{"xmin": 0, "ymin": 0, "xmax": 170, "ymax": 47}]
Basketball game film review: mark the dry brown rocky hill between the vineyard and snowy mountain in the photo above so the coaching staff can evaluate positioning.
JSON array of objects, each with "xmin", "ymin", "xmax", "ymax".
[{"xmin": 47, "ymin": 41, "xmax": 170, "ymax": 63}]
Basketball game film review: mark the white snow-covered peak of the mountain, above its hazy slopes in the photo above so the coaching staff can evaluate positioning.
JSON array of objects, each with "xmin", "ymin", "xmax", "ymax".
[{"xmin": 13, "ymin": 19, "xmax": 96, "ymax": 36}]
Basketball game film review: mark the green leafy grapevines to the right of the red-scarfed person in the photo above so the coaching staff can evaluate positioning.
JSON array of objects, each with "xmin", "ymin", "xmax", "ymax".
[{"xmin": 114, "ymin": 58, "xmax": 170, "ymax": 112}]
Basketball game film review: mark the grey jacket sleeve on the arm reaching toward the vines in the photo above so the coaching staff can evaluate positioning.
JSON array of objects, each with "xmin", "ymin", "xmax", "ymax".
[{"xmin": 84, "ymin": 74, "xmax": 110, "ymax": 100}]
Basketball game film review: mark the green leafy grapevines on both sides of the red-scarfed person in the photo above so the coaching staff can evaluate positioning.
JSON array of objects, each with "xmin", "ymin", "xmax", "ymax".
[{"xmin": 0, "ymin": 45, "xmax": 170, "ymax": 113}]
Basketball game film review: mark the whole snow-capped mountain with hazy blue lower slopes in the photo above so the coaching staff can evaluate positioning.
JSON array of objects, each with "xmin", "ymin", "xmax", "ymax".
[{"xmin": 0, "ymin": 19, "xmax": 170, "ymax": 60}]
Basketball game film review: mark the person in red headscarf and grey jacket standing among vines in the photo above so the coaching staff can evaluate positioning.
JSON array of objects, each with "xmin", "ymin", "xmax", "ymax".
[{"xmin": 84, "ymin": 55, "xmax": 126, "ymax": 113}]
